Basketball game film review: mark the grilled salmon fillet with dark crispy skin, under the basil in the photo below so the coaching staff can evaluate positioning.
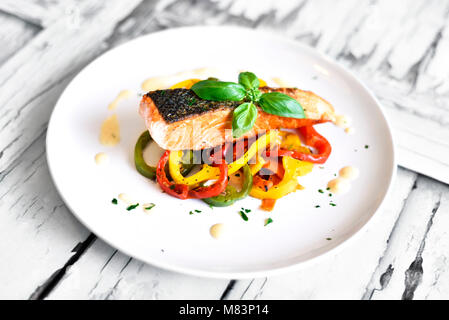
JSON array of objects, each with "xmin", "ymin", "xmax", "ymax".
[{"xmin": 139, "ymin": 87, "xmax": 335, "ymax": 150}]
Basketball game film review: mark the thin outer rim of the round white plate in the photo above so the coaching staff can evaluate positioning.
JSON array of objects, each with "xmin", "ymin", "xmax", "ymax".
[{"xmin": 45, "ymin": 26, "xmax": 397, "ymax": 279}]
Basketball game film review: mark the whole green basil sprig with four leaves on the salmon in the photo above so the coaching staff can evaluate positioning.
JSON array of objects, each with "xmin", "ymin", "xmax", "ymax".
[{"xmin": 192, "ymin": 72, "xmax": 305, "ymax": 138}]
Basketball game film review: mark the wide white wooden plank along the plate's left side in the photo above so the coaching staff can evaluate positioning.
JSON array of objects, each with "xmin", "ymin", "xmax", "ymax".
[{"xmin": 0, "ymin": 1, "xmax": 145, "ymax": 299}]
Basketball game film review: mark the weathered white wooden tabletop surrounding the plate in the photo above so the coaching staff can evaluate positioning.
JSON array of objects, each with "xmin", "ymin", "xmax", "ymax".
[{"xmin": 0, "ymin": 0, "xmax": 449, "ymax": 299}]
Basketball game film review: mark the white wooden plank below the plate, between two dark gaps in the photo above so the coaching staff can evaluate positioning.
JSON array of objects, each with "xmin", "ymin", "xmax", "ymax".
[{"xmin": 48, "ymin": 240, "xmax": 228, "ymax": 300}]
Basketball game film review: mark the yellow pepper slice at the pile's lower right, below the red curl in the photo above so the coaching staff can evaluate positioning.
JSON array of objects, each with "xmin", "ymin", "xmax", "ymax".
[{"xmin": 250, "ymin": 157, "xmax": 313, "ymax": 200}]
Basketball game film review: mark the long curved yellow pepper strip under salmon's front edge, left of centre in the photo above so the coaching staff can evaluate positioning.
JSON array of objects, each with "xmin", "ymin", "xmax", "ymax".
[{"xmin": 168, "ymin": 131, "xmax": 278, "ymax": 186}]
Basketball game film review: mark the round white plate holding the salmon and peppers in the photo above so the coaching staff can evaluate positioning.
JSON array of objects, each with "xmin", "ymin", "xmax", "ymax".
[{"xmin": 47, "ymin": 27, "xmax": 395, "ymax": 278}]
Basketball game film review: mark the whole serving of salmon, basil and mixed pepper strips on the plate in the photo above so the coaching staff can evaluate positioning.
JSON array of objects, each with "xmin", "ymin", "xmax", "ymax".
[{"xmin": 134, "ymin": 72, "xmax": 336, "ymax": 211}]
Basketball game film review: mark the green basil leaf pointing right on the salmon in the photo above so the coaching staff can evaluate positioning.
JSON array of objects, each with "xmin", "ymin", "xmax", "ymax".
[{"xmin": 259, "ymin": 92, "xmax": 306, "ymax": 119}]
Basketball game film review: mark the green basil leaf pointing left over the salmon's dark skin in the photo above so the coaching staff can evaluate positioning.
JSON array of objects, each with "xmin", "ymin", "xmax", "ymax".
[{"xmin": 192, "ymin": 80, "xmax": 246, "ymax": 101}]
